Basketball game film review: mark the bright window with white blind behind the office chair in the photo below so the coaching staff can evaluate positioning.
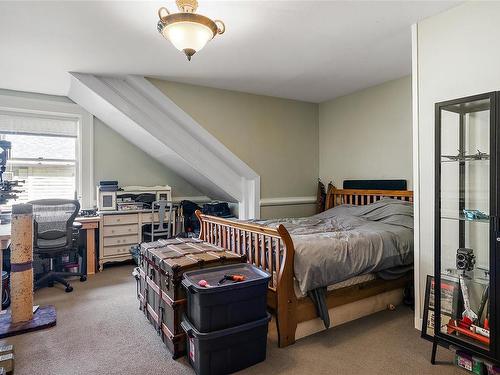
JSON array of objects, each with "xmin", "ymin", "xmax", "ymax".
[{"xmin": 0, "ymin": 111, "xmax": 79, "ymax": 209}]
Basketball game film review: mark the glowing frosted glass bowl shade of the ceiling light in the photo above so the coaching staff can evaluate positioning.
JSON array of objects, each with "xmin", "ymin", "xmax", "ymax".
[{"xmin": 162, "ymin": 21, "xmax": 214, "ymax": 52}]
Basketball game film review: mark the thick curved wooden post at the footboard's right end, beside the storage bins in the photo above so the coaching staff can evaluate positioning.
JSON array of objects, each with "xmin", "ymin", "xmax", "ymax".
[{"xmin": 276, "ymin": 224, "xmax": 297, "ymax": 348}]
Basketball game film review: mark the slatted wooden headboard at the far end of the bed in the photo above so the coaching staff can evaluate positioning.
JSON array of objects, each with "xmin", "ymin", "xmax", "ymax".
[{"xmin": 325, "ymin": 186, "xmax": 413, "ymax": 210}]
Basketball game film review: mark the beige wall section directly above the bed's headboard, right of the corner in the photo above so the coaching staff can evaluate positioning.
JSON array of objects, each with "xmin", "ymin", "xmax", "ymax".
[{"xmin": 319, "ymin": 77, "xmax": 412, "ymax": 188}]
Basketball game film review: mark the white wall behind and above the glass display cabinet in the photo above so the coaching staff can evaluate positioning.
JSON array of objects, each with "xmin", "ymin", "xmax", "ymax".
[{"xmin": 413, "ymin": 2, "xmax": 500, "ymax": 328}]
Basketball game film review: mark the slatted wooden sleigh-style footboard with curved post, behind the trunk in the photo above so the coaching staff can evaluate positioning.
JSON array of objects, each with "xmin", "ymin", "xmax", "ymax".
[{"xmin": 196, "ymin": 211, "xmax": 297, "ymax": 347}]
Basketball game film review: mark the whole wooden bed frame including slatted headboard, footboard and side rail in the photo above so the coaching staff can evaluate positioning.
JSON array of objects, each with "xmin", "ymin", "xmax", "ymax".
[{"xmin": 196, "ymin": 187, "xmax": 413, "ymax": 347}]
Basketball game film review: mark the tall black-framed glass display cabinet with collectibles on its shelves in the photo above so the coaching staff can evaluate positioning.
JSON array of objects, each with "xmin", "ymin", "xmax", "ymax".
[{"xmin": 431, "ymin": 92, "xmax": 500, "ymax": 363}]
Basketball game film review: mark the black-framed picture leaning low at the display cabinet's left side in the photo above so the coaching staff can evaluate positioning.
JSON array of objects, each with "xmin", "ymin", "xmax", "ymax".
[{"xmin": 421, "ymin": 275, "xmax": 460, "ymax": 341}]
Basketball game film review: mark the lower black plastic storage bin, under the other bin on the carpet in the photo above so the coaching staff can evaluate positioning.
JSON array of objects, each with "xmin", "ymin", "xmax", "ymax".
[{"xmin": 181, "ymin": 313, "xmax": 271, "ymax": 375}]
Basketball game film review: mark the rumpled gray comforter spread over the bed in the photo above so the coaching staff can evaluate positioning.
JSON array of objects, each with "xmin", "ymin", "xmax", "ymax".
[{"xmin": 250, "ymin": 198, "xmax": 413, "ymax": 294}]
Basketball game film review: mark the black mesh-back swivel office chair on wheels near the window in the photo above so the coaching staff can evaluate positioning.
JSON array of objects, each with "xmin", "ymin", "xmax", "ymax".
[{"xmin": 29, "ymin": 199, "xmax": 87, "ymax": 293}]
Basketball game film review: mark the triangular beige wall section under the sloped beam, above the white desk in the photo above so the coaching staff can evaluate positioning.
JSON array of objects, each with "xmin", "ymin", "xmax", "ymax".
[{"xmin": 94, "ymin": 118, "xmax": 202, "ymax": 197}]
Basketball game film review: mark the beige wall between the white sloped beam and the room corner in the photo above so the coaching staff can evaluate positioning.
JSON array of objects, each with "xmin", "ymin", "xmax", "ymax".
[{"xmin": 151, "ymin": 79, "xmax": 318, "ymax": 217}]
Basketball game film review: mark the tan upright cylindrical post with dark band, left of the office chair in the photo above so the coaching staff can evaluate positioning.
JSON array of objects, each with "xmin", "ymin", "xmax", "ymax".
[{"xmin": 10, "ymin": 204, "xmax": 33, "ymax": 324}]
